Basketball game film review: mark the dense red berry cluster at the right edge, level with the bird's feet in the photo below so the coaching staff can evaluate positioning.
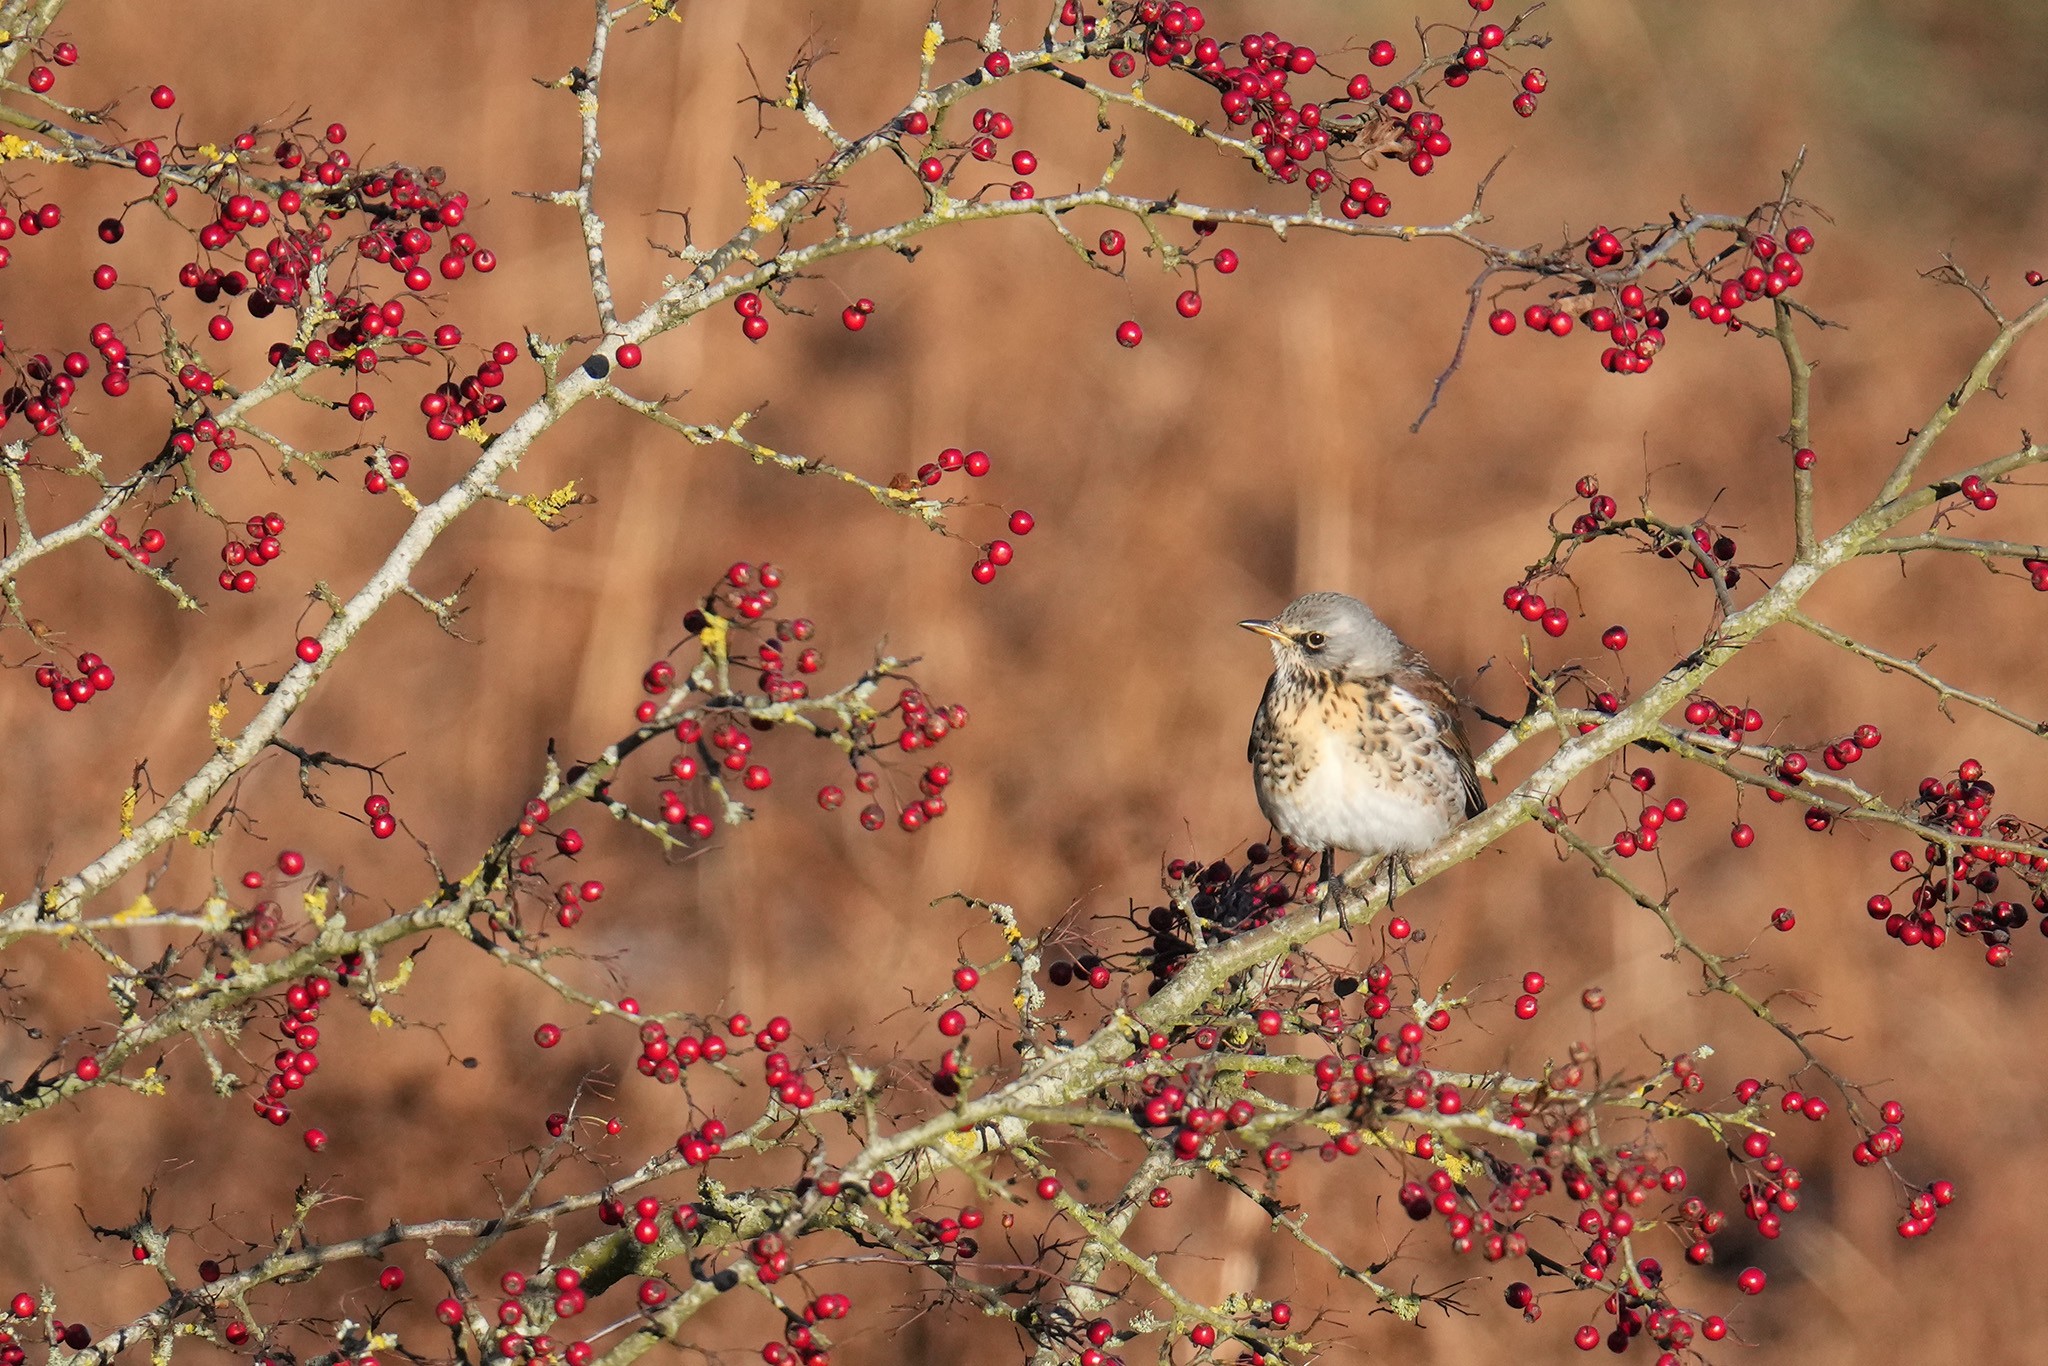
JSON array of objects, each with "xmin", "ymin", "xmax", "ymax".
[{"xmin": 1864, "ymin": 760, "xmax": 2048, "ymax": 967}]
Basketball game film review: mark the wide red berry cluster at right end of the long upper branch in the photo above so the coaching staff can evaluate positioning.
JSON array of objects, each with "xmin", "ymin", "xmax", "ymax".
[{"xmin": 1487, "ymin": 227, "xmax": 1812, "ymax": 378}]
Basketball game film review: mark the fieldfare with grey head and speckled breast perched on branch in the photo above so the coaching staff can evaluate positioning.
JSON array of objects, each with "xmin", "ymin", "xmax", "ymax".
[{"xmin": 1237, "ymin": 592, "xmax": 1487, "ymax": 893}]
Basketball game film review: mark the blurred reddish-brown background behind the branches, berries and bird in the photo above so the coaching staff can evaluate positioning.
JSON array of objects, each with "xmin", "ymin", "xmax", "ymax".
[{"xmin": 0, "ymin": 0, "xmax": 2048, "ymax": 1362}]
